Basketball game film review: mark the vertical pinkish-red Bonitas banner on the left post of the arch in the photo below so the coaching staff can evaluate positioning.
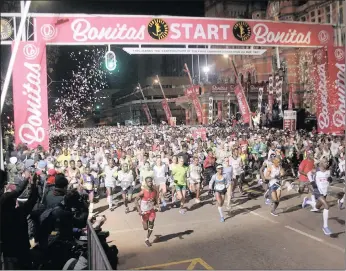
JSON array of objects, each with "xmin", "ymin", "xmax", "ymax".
[{"xmin": 13, "ymin": 41, "xmax": 49, "ymax": 151}]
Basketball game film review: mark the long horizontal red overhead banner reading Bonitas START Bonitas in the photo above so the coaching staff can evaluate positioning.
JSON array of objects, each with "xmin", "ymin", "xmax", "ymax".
[{"xmin": 34, "ymin": 14, "xmax": 334, "ymax": 47}]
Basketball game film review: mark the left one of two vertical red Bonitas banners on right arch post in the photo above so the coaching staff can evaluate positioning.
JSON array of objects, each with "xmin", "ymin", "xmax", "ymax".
[{"xmin": 313, "ymin": 48, "xmax": 331, "ymax": 133}]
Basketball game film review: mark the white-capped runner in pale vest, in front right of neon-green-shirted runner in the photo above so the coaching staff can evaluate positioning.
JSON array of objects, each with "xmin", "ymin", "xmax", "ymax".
[{"xmin": 209, "ymin": 165, "xmax": 230, "ymax": 222}]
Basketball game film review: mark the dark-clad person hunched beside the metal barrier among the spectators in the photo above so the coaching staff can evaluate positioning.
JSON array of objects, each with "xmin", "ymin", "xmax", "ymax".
[{"xmin": 33, "ymin": 190, "xmax": 88, "ymax": 270}]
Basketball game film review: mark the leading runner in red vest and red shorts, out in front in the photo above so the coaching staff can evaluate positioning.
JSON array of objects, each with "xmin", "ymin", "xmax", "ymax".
[{"xmin": 135, "ymin": 177, "xmax": 160, "ymax": 247}]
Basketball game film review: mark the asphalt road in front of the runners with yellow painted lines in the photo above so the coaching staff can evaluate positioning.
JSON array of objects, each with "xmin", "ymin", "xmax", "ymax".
[{"xmin": 95, "ymin": 184, "xmax": 346, "ymax": 270}]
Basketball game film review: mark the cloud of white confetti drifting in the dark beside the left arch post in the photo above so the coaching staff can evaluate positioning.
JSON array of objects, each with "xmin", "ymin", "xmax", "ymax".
[{"xmin": 50, "ymin": 47, "xmax": 109, "ymax": 129}]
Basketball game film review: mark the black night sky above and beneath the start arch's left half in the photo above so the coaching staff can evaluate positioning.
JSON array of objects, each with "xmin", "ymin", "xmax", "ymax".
[{"xmin": 1, "ymin": 0, "xmax": 204, "ymax": 123}]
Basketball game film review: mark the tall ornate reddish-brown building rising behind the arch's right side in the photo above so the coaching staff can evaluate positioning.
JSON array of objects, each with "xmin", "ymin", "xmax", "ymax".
[{"xmin": 205, "ymin": 0, "xmax": 345, "ymax": 113}]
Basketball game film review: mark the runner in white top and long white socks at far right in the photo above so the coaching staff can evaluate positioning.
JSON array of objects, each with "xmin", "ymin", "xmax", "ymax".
[{"xmin": 302, "ymin": 158, "xmax": 332, "ymax": 235}]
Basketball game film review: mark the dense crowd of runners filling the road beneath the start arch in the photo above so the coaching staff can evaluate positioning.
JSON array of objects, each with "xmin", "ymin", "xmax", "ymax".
[{"xmin": 2, "ymin": 125, "xmax": 345, "ymax": 249}]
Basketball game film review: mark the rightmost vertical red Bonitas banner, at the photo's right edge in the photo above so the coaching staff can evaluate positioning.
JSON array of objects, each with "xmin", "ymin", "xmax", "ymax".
[{"xmin": 328, "ymin": 47, "xmax": 346, "ymax": 135}]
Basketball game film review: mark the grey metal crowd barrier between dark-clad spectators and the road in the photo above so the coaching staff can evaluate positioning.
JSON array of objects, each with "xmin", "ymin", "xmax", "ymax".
[{"xmin": 87, "ymin": 220, "xmax": 112, "ymax": 270}]
